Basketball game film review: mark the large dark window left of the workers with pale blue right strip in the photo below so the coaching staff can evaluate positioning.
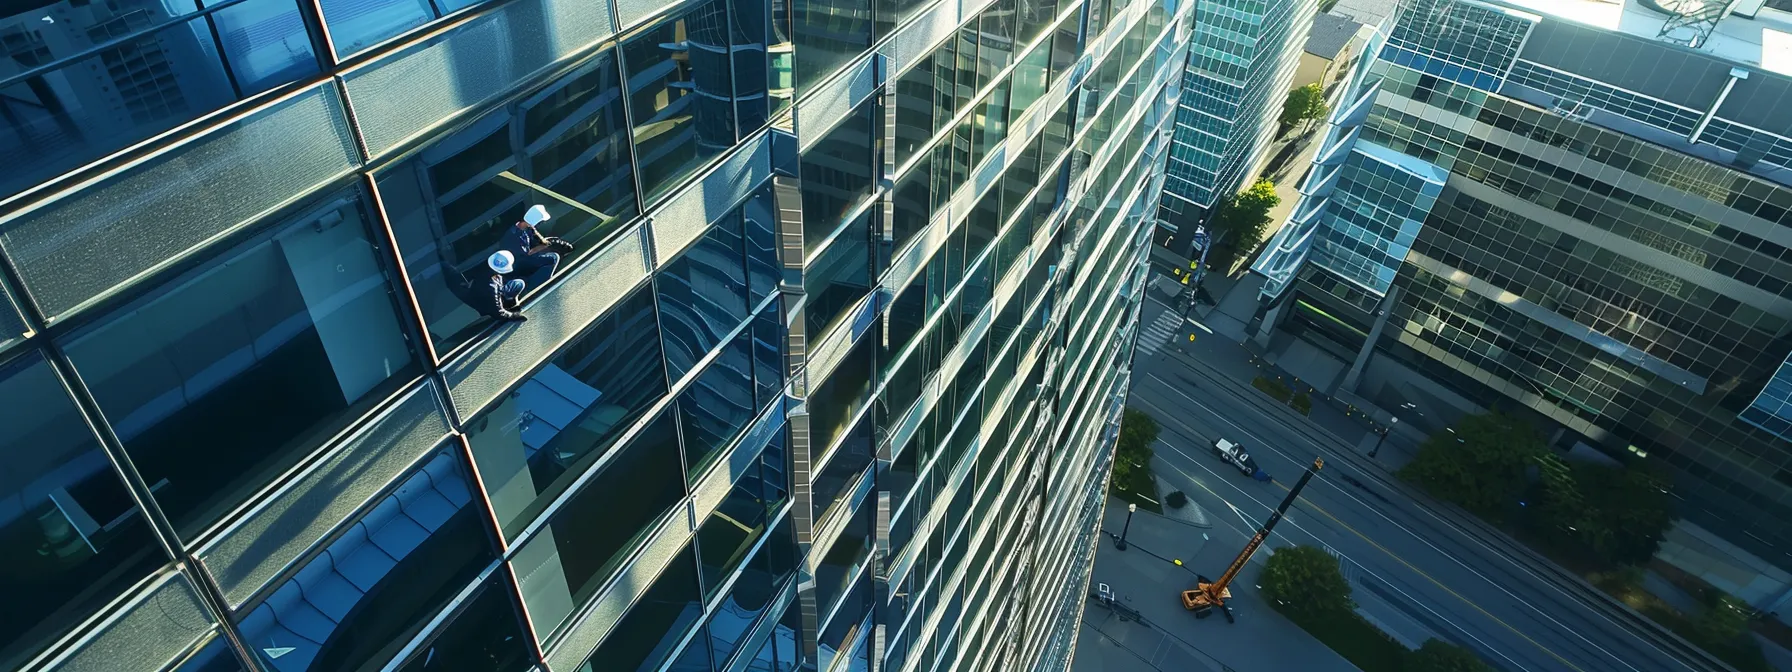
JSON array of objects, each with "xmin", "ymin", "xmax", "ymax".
[{"xmin": 68, "ymin": 192, "xmax": 418, "ymax": 532}]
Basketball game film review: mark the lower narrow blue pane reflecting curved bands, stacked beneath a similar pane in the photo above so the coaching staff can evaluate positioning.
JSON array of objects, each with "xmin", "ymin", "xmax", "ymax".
[{"xmin": 677, "ymin": 330, "xmax": 753, "ymax": 480}]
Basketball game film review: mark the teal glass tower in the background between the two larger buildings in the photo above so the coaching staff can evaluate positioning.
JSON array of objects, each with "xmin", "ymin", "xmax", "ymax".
[{"xmin": 1159, "ymin": 0, "xmax": 1319, "ymax": 247}]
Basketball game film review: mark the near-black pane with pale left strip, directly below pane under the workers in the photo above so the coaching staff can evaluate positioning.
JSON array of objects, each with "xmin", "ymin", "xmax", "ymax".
[{"xmin": 518, "ymin": 409, "xmax": 680, "ymax": 633}]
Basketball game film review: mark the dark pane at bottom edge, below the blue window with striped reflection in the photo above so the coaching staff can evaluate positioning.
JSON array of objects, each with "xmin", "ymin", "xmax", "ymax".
[{"xmin": 400, "ymin": 577, "xmax": 530, "ymax": 672}]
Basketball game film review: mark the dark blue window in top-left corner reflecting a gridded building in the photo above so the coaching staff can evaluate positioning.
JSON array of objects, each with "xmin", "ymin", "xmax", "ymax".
[{"xmin": 0, "ymin": 0, "xmax": 237, "ymax": 197}]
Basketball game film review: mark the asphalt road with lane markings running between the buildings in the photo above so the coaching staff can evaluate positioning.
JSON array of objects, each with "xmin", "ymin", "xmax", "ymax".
[{"xmin": 1129, "ymin": 308, "xmax": 1706, "ymax": 672}]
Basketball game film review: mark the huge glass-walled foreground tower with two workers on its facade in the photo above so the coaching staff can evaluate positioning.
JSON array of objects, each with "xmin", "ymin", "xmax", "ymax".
[{"xmin": 0, "ymin": 0, "xmax": 1192, "ymax": 672}]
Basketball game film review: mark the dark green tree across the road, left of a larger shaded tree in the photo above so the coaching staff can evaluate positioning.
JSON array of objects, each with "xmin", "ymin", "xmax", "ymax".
[{"xmin": 1398, "ymin": 410, "xmax": 1546, "ymax": 514}]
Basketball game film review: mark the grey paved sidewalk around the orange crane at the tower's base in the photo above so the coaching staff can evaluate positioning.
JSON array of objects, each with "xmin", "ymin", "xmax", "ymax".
[{"xmin": 1075, "ymin": 498, "xmax": 1357, "ymax": 672}]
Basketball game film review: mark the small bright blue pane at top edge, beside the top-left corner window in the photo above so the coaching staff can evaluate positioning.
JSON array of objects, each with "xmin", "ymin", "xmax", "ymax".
[{"xmin": 211, "ymin": 0, "xmax": 317, "ymax": 95}]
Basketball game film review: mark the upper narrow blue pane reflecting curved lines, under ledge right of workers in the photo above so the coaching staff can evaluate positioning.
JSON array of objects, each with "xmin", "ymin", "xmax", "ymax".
[{"xmin": 656, "ymin": 211, "xmax": 747, "ymax": 380}]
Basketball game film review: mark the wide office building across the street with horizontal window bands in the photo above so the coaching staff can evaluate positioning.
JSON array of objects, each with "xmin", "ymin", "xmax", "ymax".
[{"xmin": 1256, "ymin": 0, "xmax": 1792, "ymax": 582}]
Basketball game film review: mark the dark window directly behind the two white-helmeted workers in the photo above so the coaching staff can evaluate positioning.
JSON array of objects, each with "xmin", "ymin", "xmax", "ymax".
[{"xmin": 378, "ymin": 50, "xmax": 640, "ymax": 355}]
